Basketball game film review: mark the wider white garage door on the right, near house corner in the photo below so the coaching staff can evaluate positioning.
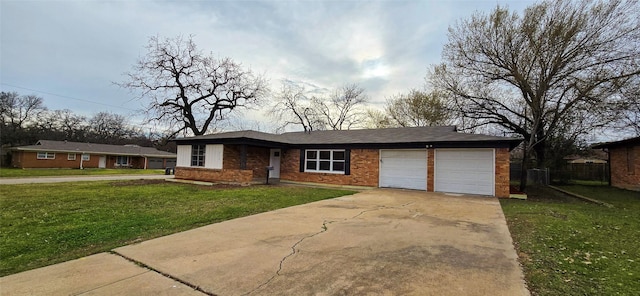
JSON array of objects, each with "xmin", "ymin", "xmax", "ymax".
[{"xmin": 435, "ymin": 149, "xmax": 495, "ymax": 195}]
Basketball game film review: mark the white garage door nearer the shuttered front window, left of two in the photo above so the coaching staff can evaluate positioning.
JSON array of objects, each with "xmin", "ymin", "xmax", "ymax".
[{"xmin": 380, "ymin": 150, "xmax": 427, "ymax": 190}]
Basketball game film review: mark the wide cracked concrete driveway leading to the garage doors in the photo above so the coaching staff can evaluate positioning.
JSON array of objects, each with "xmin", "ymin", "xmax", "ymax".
[{"xmin": 0, "ymin": 189, "xmax": 529, "ymax": 296}]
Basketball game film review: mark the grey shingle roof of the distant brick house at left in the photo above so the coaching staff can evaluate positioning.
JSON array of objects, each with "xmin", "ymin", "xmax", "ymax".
[{"xmin": 13, "ymin": 140, "xmax": 176, "ymax": 158}]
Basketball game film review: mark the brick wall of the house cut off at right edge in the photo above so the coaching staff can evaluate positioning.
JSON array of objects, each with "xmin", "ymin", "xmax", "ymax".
[{"xmin": 609, "ymin": 145, "xmax": 640, "ymax": 191}]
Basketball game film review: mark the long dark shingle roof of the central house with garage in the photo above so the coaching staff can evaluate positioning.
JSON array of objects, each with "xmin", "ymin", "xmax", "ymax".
[{"xmin": 176, "ymin": 126, "xmax": 522, "ymax": 148}]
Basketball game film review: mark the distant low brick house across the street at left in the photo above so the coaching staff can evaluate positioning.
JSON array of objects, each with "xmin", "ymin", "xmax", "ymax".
[{"xmin": 11, "ymin": 140, "xmax": 176, "ymax": 169}]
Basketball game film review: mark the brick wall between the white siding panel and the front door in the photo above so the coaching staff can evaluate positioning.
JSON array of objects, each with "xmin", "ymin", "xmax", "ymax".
[{"xmin": 222, "ymin": 145, "xmax": 270, "ymax": 178}]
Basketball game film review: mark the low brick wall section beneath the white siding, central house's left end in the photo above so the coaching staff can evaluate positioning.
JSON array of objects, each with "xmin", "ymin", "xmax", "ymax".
[{"xmin": 175, "ymin": 167, "xmax": 253, "ymax": 185}]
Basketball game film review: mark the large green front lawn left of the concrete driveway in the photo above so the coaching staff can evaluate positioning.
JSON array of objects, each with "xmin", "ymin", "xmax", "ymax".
[{"xmin": 0, "ymin": 180, "xmax": 354, "ymax": 276}]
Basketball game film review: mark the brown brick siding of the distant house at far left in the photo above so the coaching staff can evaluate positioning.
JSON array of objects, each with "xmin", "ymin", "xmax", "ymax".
[{"xmin": 11, "ymin": 151, "xmax": 150, "ymax": 169}]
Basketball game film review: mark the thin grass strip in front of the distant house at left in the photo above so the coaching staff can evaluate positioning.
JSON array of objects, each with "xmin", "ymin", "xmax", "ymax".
[{"xmin": 0, "ymin": 168, "xmax": 164, "ymax": 178}]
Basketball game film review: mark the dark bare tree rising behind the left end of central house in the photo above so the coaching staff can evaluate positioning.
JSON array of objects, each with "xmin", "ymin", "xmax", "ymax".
[{"xmin": 118, "ymin": 36, "xmax": 266, "ymax": 135}]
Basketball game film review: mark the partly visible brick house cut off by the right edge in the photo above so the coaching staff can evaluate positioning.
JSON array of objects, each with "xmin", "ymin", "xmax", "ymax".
[{"xmin": 592, "ymin": 137, "xmax": 640, "ymax": 191}]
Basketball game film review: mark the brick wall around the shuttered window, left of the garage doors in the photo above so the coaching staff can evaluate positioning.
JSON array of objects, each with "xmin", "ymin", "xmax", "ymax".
[{"xmin": 280, "ymin": 149, "xmax": 379, "ymax": 187}]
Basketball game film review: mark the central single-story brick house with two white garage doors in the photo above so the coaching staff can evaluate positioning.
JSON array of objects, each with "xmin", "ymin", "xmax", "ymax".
[{"xmin": 175, "ymin": 126, "xmax": 521, "ymax": 197}]
